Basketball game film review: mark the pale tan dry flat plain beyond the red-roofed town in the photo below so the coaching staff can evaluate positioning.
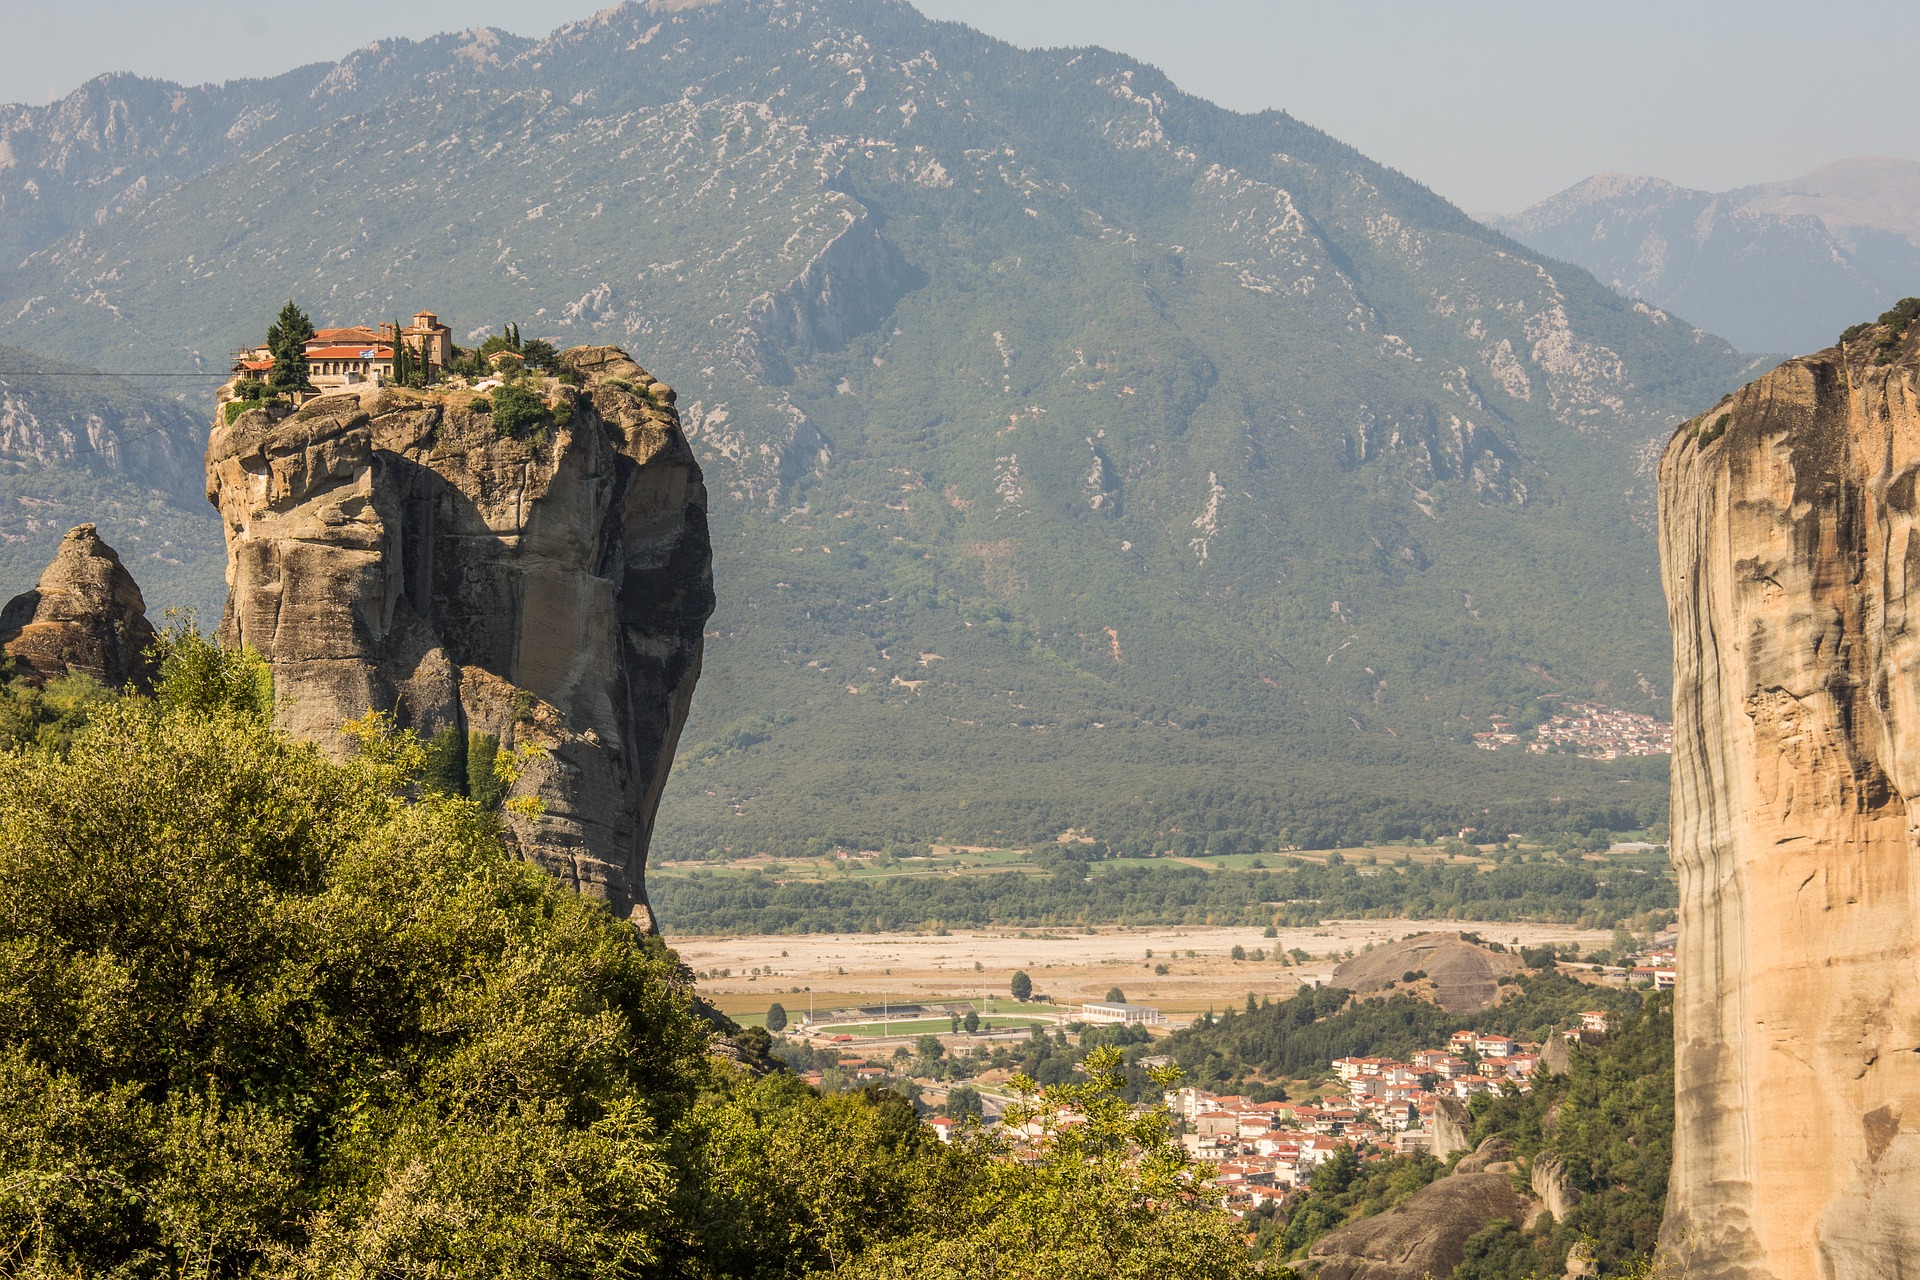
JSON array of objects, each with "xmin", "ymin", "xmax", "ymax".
[{"xmin": 668, "ymin": 919, "xmax": 1613, "ymax": 1017}]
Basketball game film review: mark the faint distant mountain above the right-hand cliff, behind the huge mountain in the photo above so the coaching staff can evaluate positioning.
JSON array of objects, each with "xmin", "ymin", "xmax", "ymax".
[{"xmin": 1492, "ymin": 157, "xmax": 1920, "ymax": 351}]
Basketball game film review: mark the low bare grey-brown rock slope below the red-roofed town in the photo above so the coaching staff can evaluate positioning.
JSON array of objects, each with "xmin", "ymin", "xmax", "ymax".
[{"xmin": 1308, "ymin": 1138, "xmax": 1534, "ymax": 1280}]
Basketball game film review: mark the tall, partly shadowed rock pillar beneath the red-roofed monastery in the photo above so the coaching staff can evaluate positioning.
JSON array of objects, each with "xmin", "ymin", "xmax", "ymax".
[{"xmin": 205, "ymin": 347, "xmax": 712, "ymax": 927}]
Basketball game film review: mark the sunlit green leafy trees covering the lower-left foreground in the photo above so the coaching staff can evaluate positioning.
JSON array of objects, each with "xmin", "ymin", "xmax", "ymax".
[{"xmin": 0, "ymin": 652, "xmax": 1244, "ymax": 1280}]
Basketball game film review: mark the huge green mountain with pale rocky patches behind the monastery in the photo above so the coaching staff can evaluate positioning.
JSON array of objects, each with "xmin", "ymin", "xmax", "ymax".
[{"xmin": 0, "ymin": 0, "xmax": 1749, "ymax": 856}]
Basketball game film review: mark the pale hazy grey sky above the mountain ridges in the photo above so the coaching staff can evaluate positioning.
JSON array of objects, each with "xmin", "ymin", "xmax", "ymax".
[{"xmin": 0, "ymin": 0, "xmax": 1920, "ymax": 213}]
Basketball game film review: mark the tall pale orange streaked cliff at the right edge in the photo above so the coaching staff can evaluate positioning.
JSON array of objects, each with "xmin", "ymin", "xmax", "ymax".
[{"xmin": 1661, "ymin": 314, "xmax": 1920, "ymax": 1280}]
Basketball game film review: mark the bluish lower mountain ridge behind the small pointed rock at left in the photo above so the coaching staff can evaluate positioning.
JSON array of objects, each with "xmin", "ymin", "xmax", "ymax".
[{"xmin": 0, "ymin": 345, "xmax": 227, "ymax": 624}]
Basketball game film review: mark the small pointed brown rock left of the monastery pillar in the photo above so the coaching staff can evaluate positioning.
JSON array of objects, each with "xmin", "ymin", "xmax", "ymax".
[{"xmin": 0, "ymin": 524, "xmax": 154, "ymax": 689}]
